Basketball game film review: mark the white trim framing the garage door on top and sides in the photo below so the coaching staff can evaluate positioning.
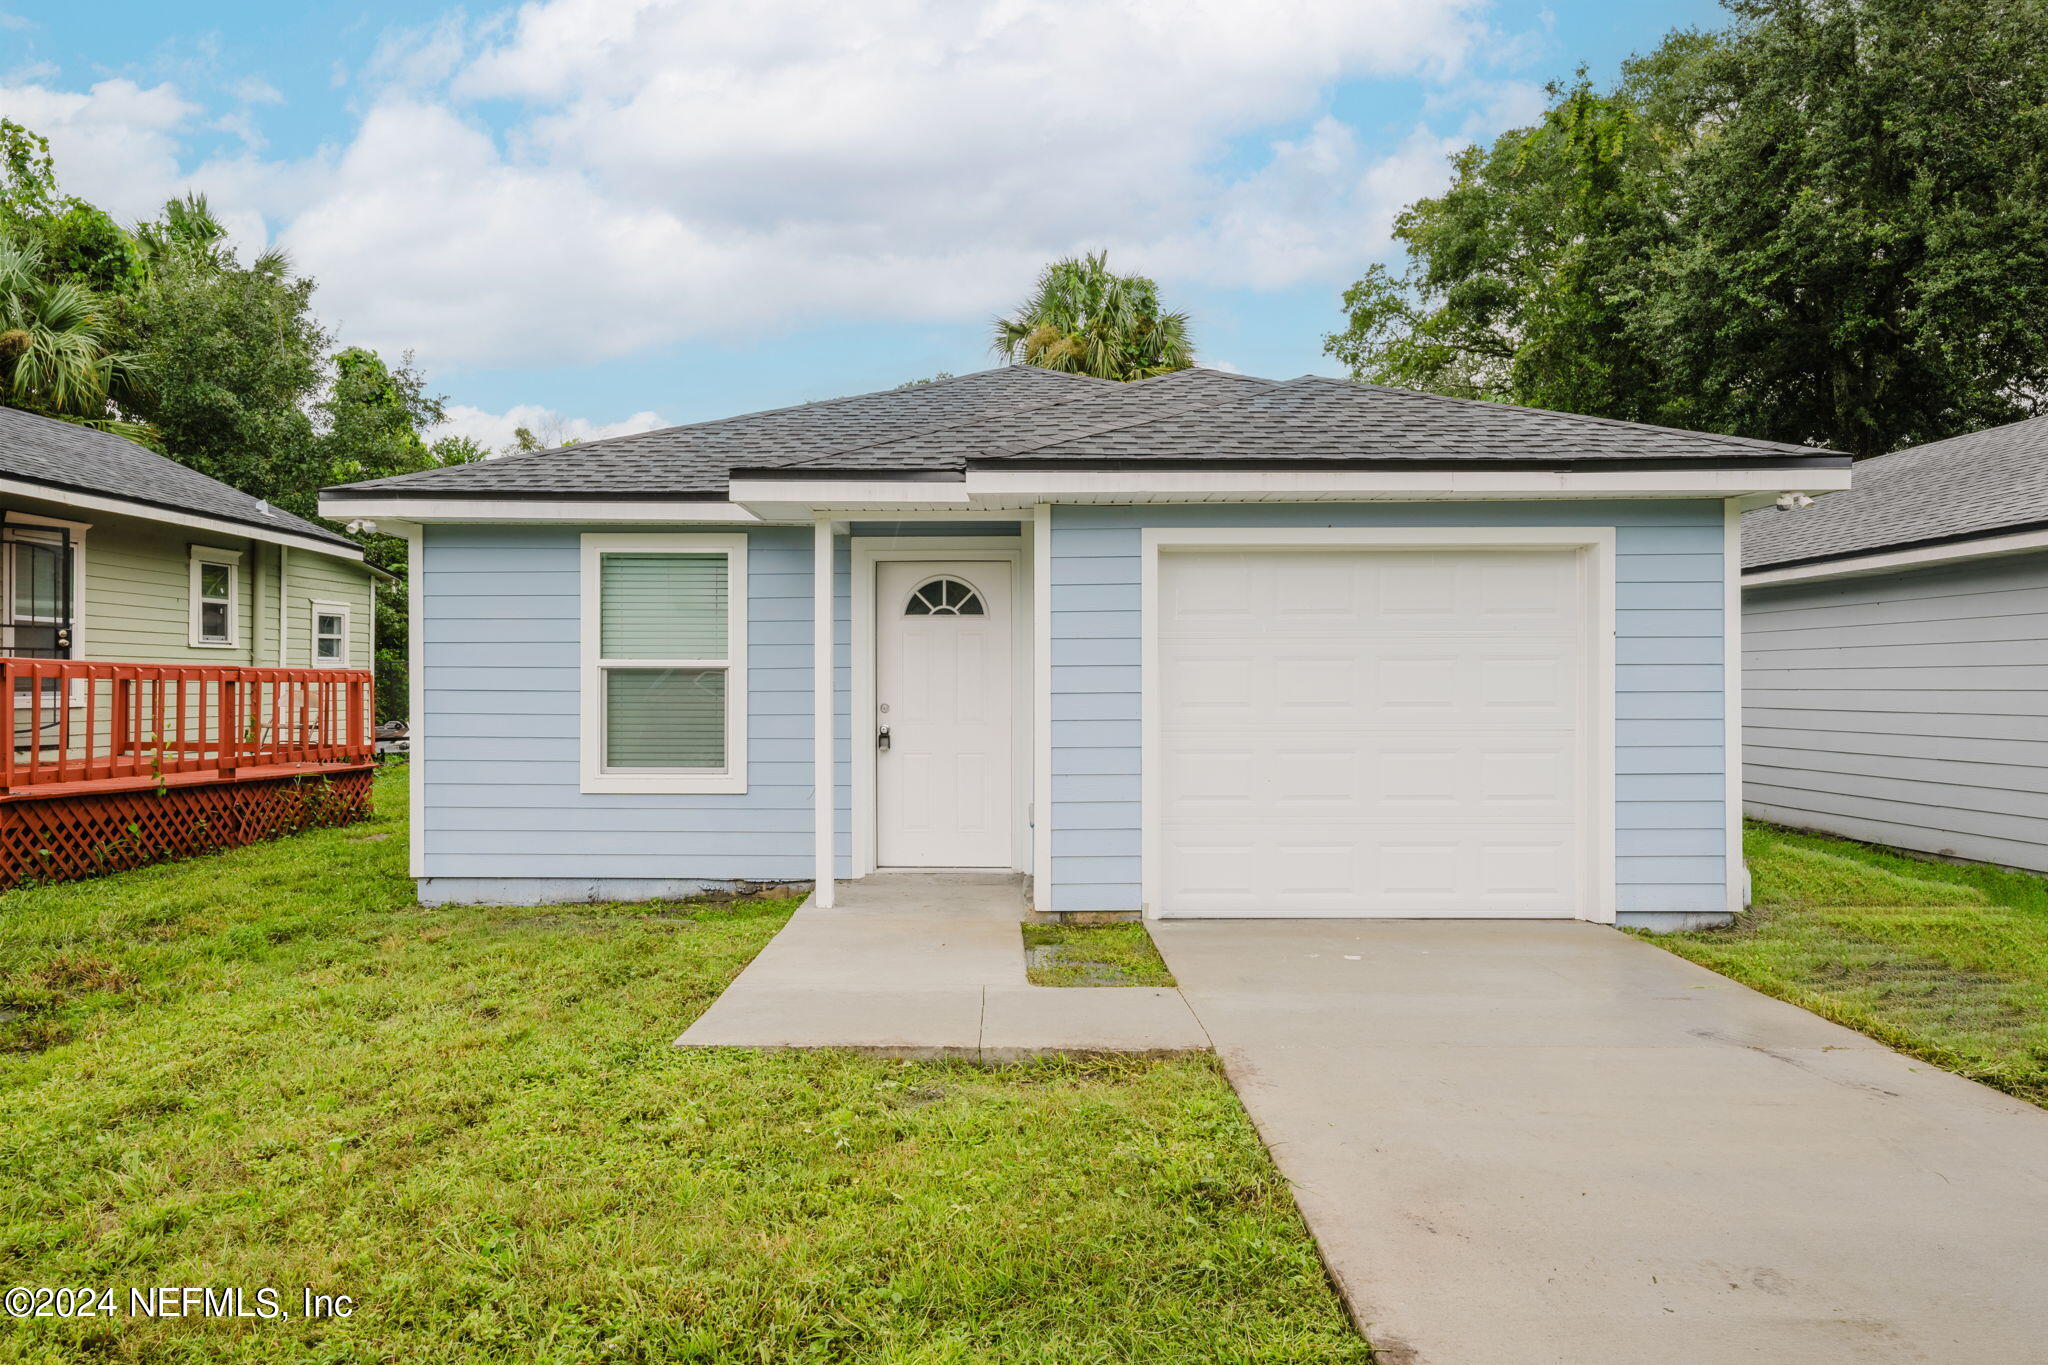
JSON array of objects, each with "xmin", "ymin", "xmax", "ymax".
[{"xmin": 1139, "ymin": 526, "xmax": 1616, "ymax": 925}]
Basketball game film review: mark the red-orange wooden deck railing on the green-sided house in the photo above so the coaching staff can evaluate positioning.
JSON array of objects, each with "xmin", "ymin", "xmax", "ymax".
[{"xmin": 0, "ymin": 659, "xmax": 375, "ymax": 800}]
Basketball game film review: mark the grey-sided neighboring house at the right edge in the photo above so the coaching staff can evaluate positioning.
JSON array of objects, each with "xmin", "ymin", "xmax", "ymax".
[{"xmin": 1743, "ymin": 417, "xmax": 2048, "ymax": 872}]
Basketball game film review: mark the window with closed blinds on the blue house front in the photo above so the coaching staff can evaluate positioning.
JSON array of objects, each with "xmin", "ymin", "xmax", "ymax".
[{"xmin": 592, "ymin": 548, "xmax": 735, "ymax": 776}]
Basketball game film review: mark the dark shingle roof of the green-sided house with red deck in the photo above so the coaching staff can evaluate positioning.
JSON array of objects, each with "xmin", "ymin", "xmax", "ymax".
[{"xmin": 0, "ymin": 407, "xmax": 356, "ymax": 548}]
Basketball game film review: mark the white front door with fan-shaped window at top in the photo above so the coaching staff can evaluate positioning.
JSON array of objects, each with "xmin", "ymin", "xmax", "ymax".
[{"xmin": 872, "ymin": 561, "xmax": 1016, "ymax": 868}]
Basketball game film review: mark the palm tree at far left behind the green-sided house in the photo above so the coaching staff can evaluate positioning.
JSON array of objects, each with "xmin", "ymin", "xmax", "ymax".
[{"xmin": 0, "ymin": 239, "xmax": 150, "ymax": 438}]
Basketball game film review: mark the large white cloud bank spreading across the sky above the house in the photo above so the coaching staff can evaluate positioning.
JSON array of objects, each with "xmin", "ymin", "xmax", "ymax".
[{"xmin": 12, "ymin": 0, "xmax": 1518, "ymax": 378}]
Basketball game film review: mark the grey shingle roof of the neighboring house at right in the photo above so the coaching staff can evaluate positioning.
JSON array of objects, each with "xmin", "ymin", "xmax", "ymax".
[{"xmin": 1743, "ymin": 417, "xmax": 2048, "ymax": 569}]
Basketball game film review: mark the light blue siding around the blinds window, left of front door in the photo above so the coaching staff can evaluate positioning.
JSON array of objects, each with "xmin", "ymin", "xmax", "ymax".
[{"xmin": 418, "ymin": 526, "xmax": 850, "ymax": 880}]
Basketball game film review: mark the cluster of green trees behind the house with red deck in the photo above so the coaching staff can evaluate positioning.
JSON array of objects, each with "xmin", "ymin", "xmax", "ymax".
[{"xmin": 0, "ymin": 119, "xmax": 487, "ymax": 716}]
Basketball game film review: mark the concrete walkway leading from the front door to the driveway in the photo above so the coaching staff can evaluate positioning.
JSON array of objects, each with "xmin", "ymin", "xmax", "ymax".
[{"xmin": 676, "ymin": 872, "xmax": 1208, "ymax": 1062}]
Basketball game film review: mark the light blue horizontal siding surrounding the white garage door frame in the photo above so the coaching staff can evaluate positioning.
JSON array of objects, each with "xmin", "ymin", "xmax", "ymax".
[{"xmin": 1049, "ymin": 499, "xmax": 1726, "ymax": 913}]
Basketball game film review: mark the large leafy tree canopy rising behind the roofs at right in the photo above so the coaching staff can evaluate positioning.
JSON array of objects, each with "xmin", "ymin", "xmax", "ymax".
[{"xmin": 1325, "ymin": 0, "xmax": 2048, "ymax": 456}]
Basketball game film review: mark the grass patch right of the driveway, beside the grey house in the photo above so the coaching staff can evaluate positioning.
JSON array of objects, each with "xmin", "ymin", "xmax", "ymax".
[{"xmin": 1651, "ymin": 823, "xmax": 2048, "ymax": 1105}]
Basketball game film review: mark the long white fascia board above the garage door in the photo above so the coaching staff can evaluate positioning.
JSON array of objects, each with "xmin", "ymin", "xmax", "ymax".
[{"xmin": 965, "ymin": 467, "xmax": 1849, "ymax": 505}]
